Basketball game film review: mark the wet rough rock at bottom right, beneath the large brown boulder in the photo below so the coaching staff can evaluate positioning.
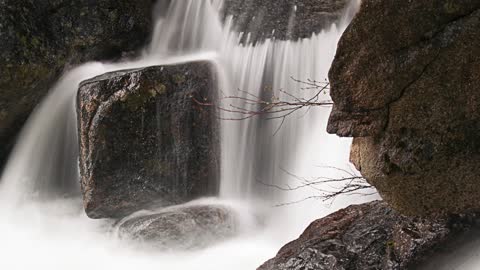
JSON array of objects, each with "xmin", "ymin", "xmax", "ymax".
[{"xmin": 258, "ymin": 201, "xmax": 477, "ymax": 270}]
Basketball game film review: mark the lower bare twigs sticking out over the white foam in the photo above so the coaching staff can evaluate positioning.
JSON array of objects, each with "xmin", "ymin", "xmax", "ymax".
[{"xmin": 257, "ymin": 167, "xmax": 376, "ymax": 206}]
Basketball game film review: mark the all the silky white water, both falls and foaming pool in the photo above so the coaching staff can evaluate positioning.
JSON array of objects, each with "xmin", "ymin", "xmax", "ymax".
[{"xmin": 0, "ymin": 0, "xmax": 376, "ymax": 270}]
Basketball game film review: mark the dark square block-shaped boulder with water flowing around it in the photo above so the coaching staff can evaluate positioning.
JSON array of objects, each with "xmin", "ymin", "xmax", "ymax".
[{"xmin": 77, "ymin": 62, "xmax": 219, "ymax": 218}]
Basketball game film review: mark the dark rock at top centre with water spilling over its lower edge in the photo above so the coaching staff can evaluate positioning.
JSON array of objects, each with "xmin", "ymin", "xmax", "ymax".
[{"xmin": 224, "ymin": 0, "xmax": 350, "ymax": 42}]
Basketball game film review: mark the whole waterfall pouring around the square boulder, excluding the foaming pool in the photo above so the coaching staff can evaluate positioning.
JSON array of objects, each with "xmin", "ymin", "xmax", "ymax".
[{"xmin": 2, "ymin": 0, "xmax": 360, "ymax": 206}]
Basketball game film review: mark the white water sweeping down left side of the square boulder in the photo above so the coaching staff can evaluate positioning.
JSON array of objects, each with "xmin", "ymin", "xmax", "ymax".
[{"xmin": 0, "ymin": 63, "xmax": 104, "ymax": 201}]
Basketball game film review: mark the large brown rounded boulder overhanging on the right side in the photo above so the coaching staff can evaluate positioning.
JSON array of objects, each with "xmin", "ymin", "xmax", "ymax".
[{"xmin": 328, "ymin": 0, "xmax": 480, "ymax": 215}]
